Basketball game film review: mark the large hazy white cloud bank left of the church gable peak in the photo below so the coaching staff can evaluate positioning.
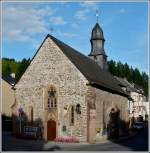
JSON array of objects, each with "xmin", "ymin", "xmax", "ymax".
[{"xmin": 2, "ymin": 6, "xmax": 53, "ymax": 41}]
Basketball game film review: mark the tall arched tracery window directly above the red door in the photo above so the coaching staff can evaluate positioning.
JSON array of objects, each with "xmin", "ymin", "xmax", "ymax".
[{"xmin": 47, "ymin": 87, "xmax": 57, "ymax": 108}]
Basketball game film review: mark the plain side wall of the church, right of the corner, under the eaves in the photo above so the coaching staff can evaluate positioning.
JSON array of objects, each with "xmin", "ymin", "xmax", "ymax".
[{"xmin": 88, "ymin": 86, "xmax": 129, "ymax": 136}]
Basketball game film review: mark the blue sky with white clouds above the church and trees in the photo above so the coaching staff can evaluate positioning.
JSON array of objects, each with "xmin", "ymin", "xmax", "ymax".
[{"xmin": 2, "ymin": 2, "xmax": 148, "ymax": 73}]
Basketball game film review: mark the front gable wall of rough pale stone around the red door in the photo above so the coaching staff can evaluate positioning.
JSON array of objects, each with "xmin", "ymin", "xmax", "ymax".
[{"xmin": 15, "ymin": 38, "xmax": 87, "ymax": 141}]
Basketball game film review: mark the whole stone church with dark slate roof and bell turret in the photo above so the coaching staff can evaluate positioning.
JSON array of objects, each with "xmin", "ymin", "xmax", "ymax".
[{"xmin": 12, "ymin": 23, "xmax": 129, "ymax": 142}]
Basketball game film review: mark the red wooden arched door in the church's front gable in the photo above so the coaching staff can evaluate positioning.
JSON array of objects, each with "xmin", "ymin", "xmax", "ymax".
[{"xmin": 47, "ymin": 120, "xmax": 56, "ymax": 140}]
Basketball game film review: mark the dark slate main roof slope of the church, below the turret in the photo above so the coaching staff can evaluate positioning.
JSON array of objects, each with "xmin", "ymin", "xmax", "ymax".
[{"xmin": 47, "ymin": 35, "xmax": 128, "ymax": 96}]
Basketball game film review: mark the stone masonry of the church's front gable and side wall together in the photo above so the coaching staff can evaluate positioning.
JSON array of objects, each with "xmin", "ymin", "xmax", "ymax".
[{"xmin": 13, "ymin": 37, "xmax": 128, "ymax": 141}]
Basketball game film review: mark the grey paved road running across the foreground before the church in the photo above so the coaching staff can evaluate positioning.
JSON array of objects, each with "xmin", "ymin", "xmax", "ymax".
[{"xmin": 2, "ymin": 127, "xmax": 148, "ymax": 151}]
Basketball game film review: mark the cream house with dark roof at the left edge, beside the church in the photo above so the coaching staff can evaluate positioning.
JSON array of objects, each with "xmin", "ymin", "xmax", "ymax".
[{"xmin": 1, "ymin": 74, "xmax": 16, "ymax": 117}]
